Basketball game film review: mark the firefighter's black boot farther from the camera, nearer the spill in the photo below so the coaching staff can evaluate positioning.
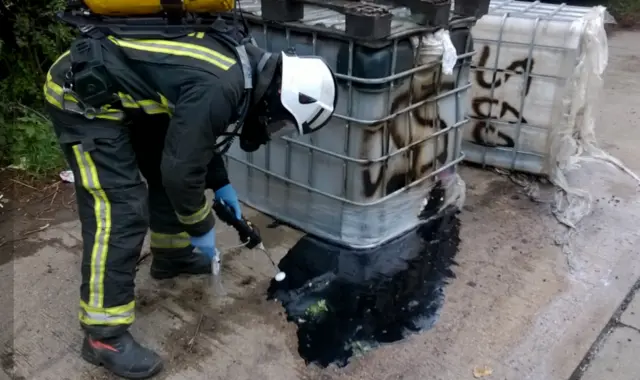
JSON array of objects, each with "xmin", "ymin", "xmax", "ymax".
[{"xmin": 151, "ymin": 251, "xmax": 211, "ymax": 280}]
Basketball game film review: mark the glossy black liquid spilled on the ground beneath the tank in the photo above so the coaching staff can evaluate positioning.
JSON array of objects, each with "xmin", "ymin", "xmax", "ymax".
[{"xmin": 268, "ymin": 188, "xmax": 460, "ymax": 367}]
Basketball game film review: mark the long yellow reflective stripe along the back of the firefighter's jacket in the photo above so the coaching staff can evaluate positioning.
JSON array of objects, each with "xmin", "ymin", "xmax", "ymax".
[{"xmin": 109, "ymin": 36, "xmax": 236, "ymax": 71}]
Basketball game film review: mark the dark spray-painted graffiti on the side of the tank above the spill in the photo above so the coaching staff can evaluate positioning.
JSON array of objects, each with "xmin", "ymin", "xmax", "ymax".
[{"xmin": 360, "ymin": 37, "xmax": 454, "ymax": 198}]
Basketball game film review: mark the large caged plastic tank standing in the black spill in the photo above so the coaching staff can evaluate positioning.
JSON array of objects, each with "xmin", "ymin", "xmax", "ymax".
[{"xmin": 222, "ymin": 0, "xmax": 471, "ymax": 248}]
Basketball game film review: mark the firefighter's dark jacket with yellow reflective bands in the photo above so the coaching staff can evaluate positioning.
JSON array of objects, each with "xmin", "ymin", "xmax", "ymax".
[{"xmin": 44, "ymin": 32, "xmax": 255, "ymax": 236}]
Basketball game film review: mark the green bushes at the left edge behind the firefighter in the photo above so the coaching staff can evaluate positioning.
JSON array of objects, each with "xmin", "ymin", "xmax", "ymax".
[{"xmin": 0, "ymin": 0, "xmax": 72, "ymax": 175}]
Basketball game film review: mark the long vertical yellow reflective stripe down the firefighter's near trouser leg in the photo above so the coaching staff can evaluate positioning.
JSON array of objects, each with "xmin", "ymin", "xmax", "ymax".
[{"xmin": 73, "ymin": 144, "xmax": 111, "ymax": 308}]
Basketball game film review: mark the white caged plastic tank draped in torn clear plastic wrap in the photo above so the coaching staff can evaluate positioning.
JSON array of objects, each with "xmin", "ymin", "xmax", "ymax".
[{"xmin": 463, "ymin": 0, "xmax": 635, "ymax": 227}]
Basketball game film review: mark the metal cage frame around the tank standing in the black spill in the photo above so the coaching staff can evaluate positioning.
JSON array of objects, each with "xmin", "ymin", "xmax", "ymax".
[{"xmin": 226, "ymin": 8, "xmax": 475, "ymax": 248}]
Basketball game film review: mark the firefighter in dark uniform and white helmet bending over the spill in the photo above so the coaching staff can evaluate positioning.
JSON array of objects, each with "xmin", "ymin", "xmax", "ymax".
[{"xmin": 44, "ymin": 22, "xmax": 337, "ymax": 379}]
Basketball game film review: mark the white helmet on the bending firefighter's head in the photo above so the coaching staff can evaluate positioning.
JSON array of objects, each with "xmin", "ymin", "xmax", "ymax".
[{"xmin": 267, "ymin": 52, "xmax": 338, "ymax": 138}]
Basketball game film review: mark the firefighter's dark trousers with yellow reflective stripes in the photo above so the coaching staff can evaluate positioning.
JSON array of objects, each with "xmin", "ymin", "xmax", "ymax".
[{"xmin": 48, "ymin": 106, "xmax": 208, "ymax": 339}]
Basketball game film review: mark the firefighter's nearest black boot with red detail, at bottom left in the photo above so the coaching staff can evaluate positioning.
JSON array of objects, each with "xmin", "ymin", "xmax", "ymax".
[{"xmin": 82, "ymin": 332, "xmax": 162, "ymax": 379}]
